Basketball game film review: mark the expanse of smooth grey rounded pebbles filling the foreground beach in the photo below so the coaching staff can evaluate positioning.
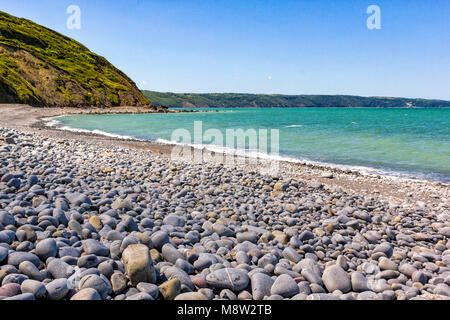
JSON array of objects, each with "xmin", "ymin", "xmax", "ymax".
[{"xmin": 0, "ymin": 105, "xmax": 450, "ymax": 300}]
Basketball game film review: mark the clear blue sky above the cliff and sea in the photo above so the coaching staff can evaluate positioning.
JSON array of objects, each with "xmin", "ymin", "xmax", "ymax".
[{"xmin": 0, "ymin": 0, "xmax": 450, "ymax": 100}]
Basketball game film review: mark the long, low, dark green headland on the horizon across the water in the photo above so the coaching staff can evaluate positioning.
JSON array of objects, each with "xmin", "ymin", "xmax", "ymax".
[{"xmin": 143, "ymin": 91, "xmax": 450, "ymax": 108}]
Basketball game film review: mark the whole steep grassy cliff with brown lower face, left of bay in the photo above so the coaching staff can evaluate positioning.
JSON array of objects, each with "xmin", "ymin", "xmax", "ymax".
[{"xmin": 0, "ymin": 11, "xmax": 150, "ymax": 107}]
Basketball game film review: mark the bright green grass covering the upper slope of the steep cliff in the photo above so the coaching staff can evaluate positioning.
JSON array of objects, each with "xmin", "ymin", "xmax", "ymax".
[{"xmin": 0, "ymin": 11, "xmax": 148, "ymax": 103}]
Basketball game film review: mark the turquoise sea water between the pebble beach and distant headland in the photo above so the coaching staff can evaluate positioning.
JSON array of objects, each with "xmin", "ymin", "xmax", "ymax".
[{"xmin": 51, "ymin": 108, "xmax": 450, "ymax": 182}]
